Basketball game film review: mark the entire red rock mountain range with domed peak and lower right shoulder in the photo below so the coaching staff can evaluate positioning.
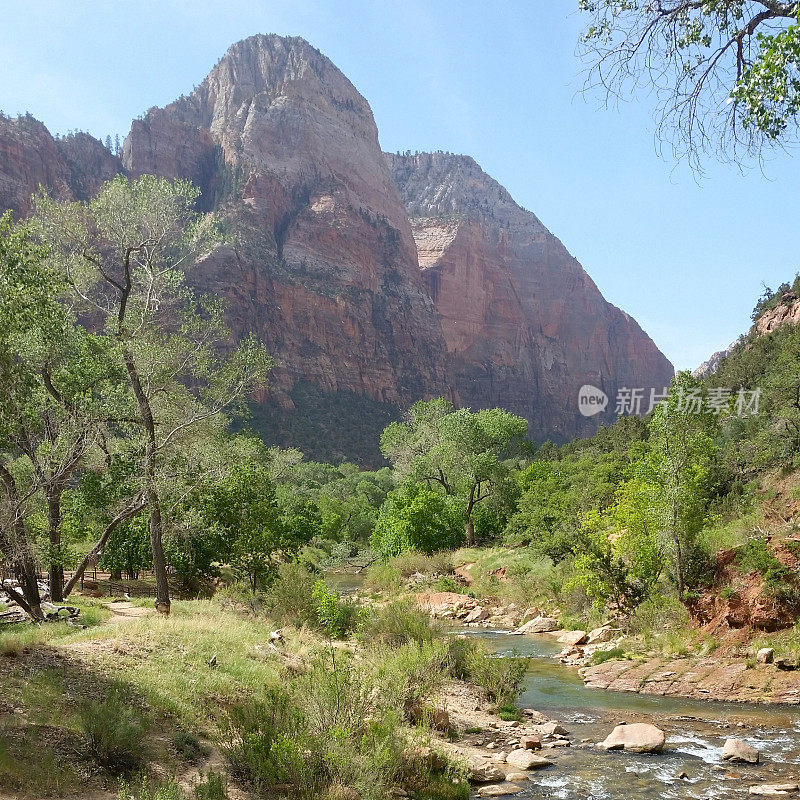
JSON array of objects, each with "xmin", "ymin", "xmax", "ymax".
[{"xmin": 0, "ymin": 36, "xmax": 672, "ymax": 462}]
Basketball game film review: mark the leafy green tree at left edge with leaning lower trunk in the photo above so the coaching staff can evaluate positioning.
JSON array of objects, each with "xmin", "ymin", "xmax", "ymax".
[{"xmin": 0, "ymin": 216, "xmax": 149, "ymax": 618}]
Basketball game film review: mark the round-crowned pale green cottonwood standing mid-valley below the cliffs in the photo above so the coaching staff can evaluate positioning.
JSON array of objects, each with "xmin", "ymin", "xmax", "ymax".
[{"xmin": 381, "ymin": 398, "xmax": 528, "ymax": 546}]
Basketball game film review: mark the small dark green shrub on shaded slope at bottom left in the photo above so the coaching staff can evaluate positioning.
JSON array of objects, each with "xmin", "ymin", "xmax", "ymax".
[{"xmin": 78, "ymin": 690, "xmax": 148, "ymax": 774}]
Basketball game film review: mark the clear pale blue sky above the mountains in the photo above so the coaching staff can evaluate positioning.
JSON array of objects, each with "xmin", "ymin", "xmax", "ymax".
[{"xmin": 0, "ymin": 0, "xmax": 800, "ymax": 368}]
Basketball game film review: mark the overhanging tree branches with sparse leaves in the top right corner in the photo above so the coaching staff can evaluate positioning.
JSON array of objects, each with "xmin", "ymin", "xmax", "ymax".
[{"xmin": 579, "ymin": 0, "xmax": 800, "ymax": 168}]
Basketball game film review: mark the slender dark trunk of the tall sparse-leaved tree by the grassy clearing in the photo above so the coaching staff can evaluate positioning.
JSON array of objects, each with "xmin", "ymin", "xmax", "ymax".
[{"xmin": 123, "ymin": 348, "xmax": 170, "ymax": 614}]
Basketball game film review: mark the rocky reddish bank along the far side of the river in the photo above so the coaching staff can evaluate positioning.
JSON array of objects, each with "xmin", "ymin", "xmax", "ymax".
[{"xmin": 364, "ymin": 551, "xmax": 800, "ymax": 705}]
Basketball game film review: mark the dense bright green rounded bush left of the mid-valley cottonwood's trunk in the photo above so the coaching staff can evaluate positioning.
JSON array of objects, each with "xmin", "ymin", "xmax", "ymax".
[{"xmin": 370, "ymin": 483, "xmax": 463, "ymax": 558}]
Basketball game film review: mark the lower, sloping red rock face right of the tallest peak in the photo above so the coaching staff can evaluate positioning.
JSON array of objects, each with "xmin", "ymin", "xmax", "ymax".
[{"xmin": 387, "ymin": 153, "xmax": 673, "ymax": 440}]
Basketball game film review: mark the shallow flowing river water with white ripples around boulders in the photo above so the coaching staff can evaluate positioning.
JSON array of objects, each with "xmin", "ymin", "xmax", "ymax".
[{"xmin": 458, "ymin": 628, "xmax": 800, "ymax": 800}]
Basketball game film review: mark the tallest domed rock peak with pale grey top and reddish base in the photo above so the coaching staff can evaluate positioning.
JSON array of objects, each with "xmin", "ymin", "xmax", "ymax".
[{"xmin": 123, "ymin": 36, "xmax": 453, "ymax": 438}]
